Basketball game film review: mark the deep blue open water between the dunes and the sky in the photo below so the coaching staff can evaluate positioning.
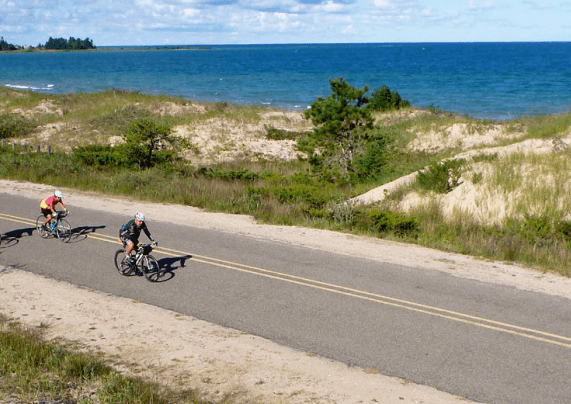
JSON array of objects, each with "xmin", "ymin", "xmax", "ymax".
[{"xmin": 0, "ymin": 42, "xmax": 571, "ymax": 120}]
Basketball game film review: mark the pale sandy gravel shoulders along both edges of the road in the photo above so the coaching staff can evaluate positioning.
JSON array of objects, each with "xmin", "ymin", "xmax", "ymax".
[{"xmin": 0, "ymin": 180, "xmax": 571, "ymax": 404}]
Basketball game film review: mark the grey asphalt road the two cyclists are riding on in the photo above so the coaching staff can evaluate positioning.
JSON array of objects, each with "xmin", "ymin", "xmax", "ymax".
[{"xmin": 0, "ymin": 194, "xmax": 571, "ymax": 404}]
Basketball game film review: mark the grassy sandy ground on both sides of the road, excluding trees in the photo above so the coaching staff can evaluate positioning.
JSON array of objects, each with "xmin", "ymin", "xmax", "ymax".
[{"xmin": 0, "ymin": 88, "xmax": 571, "ymax": 403}]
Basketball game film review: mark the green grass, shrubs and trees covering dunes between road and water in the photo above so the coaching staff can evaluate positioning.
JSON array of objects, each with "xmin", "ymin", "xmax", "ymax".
[{"xmin": 0, "ymin": 79, "xmax": 571, "ymax": 276}]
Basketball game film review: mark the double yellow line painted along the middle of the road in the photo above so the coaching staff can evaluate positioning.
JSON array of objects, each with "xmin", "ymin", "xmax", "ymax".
[{"xmin": 0, "ymin": 213, "xmax": 571, "ymax": 348}]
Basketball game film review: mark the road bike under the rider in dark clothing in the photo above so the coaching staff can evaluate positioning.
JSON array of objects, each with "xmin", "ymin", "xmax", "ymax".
[{"xmin": 115, "ymin": 242, "xmax": 166, "ymax": 282}]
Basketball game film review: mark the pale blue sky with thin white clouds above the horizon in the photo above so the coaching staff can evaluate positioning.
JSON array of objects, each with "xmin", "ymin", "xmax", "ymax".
[{"xmin": 0, "ymin": 0, "xmax": 571, "ymax": 46}]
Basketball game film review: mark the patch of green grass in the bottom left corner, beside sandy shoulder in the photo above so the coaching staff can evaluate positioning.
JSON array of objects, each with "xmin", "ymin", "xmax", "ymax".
[{"xmin": 0, "ymin": 316, "xmax": 211, "ymax": 404}]
